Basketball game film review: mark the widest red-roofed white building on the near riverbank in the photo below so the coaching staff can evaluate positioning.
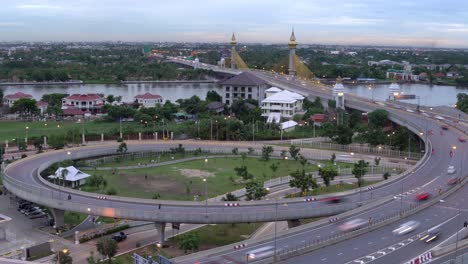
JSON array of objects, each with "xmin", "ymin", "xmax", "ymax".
[{"xmin": 62, "ymin": 94, "xmax": 106, "ymax": 113}]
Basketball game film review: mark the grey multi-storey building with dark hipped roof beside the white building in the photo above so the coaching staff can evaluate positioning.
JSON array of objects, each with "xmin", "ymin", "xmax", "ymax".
[{"xmin": 219, "ymin": 72, "xmax": 268, "ymax": 106}]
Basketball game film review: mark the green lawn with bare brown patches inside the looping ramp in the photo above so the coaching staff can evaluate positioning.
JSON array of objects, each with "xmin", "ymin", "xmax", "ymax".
[{"xmin": 82, "ymin": 157, "xmax": 317, "ymax": 200}]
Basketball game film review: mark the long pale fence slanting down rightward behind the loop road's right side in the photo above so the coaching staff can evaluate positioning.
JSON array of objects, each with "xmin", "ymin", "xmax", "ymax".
[{"xmin": 290, "ymin": 139, "xmax": 424, "ymax": 160}]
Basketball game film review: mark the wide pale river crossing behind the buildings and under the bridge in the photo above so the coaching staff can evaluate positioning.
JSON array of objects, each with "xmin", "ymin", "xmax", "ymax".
[{"xmin": 0, "ymin": 83, "xmax": 468, "ymax": 106}]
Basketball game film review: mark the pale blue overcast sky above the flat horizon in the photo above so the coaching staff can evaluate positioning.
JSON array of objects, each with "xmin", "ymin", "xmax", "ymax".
[{"xmin": 0, "ymin": 0, "xmax": 468, "ymax": 47}]
